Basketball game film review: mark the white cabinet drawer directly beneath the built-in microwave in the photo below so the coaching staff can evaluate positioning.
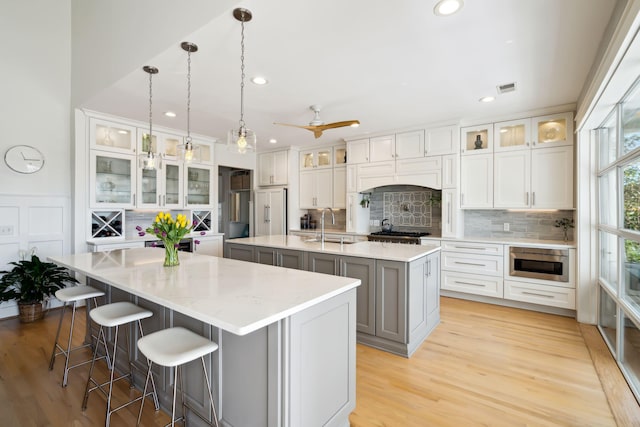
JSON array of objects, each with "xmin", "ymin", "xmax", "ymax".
[{"xmin": 504, "ymin": 280, "xmax": 576, "ymax": 310}]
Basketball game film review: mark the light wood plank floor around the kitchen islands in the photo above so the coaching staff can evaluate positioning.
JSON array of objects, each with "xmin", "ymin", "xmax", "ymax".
[{"xmin": 0, "ymin": 298, "xmax": 640, "ymax": 427}]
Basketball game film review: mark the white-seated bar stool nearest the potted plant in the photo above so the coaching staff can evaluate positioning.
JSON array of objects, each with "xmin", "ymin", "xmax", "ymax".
[{"xmin": 49, "ymin": 285, "xmax": 110, "ymax": 387}]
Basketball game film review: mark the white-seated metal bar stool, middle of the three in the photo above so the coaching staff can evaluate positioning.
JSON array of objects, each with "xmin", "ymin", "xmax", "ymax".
[{"xmin": 82, "ymin": 302, "xmax": 160, "ymax": 427}]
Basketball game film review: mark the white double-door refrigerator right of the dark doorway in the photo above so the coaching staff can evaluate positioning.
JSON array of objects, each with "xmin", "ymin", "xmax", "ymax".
[{"xmin": 254, "ymin": 188, "xmax": 288, "ymax": 236}]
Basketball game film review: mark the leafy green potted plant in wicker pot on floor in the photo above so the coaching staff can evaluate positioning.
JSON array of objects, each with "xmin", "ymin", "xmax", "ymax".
[{"xmin": 0, "ymin": 254, "xmax": 78, "ymax": 323}]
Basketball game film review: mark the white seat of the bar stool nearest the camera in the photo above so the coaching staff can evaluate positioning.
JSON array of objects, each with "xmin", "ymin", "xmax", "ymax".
[{"xmin": 138, "ymin": 327, "xmax": 218, "ymax": 367}]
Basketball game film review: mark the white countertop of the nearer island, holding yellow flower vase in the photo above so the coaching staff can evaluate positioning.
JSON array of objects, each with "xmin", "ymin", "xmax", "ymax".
[{"xmin": 49, "ymin": 248, "xmax": 360, "ymax": 335}]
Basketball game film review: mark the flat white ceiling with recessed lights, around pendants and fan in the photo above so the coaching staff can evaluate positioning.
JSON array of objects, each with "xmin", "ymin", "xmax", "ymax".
[{"xmin": 82, "ymin": 0, "xmax": 615, "ymax": 151}]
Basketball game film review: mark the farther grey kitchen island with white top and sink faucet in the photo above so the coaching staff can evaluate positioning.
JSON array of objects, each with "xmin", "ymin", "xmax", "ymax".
[{"xmin": 224, "ymin": 235, "xmax": 440, "ymax": 357}]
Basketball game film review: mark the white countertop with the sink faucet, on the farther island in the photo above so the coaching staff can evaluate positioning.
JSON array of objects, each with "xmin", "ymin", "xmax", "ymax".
[{"xmin": 227, "ymin": 235, "xmax": 440, "ymax": 262}]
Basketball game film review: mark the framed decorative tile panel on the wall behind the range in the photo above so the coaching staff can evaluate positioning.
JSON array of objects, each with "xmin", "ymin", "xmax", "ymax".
[{"xmin": 383, "ymin": 191, "xmax": 432, "ymax": 227}]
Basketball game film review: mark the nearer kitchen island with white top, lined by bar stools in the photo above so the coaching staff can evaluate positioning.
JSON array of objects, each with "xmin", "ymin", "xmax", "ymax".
[{"xmin": 49, "ymin": 248, "xmax": 360, "ymax": 427}]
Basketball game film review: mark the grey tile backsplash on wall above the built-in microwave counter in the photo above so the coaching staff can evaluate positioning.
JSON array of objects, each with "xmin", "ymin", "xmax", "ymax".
[{"xmin": 464, "ymin": 210, "xmax": 574, "ymax": 241}]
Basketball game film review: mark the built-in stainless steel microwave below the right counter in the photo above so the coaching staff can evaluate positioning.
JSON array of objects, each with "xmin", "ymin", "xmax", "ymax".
[{"xmin": 509, "ymin": 246, "xmax": 569, "ymax": 282}]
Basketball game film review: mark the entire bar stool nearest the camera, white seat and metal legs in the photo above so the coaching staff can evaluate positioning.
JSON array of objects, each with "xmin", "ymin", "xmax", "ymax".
[{"xmin": 137, "ymin": 327, "xmax": 218, "ymax": 427}]
